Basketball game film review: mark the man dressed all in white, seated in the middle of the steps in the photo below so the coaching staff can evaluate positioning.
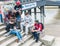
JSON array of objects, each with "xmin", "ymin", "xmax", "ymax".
[{"xmin": 21, "ymin": 12, "xmax": 32, "ymax": 35}]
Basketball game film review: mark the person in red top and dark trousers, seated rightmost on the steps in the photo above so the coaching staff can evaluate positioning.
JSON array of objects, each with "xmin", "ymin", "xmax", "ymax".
[{"xmin": 32, "ymin": 20, "xmax": 43, "ymax": 42}]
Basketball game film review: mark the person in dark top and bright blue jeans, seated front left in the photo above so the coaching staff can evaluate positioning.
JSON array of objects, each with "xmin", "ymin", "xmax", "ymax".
[{"xmin": 7, "ymin": 19, "xmax": 22, "ymax": 42}]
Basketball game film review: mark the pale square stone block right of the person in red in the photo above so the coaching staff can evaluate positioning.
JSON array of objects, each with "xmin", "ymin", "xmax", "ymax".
[{"xmin": 41, "ymin": 35, "xmax": 55, "ymax": 46}]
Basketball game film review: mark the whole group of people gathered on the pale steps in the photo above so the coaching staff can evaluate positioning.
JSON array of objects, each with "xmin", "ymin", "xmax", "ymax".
[{"xmin": 4, "ymin": 1, "xmax": 44, "ymax": 43}]
